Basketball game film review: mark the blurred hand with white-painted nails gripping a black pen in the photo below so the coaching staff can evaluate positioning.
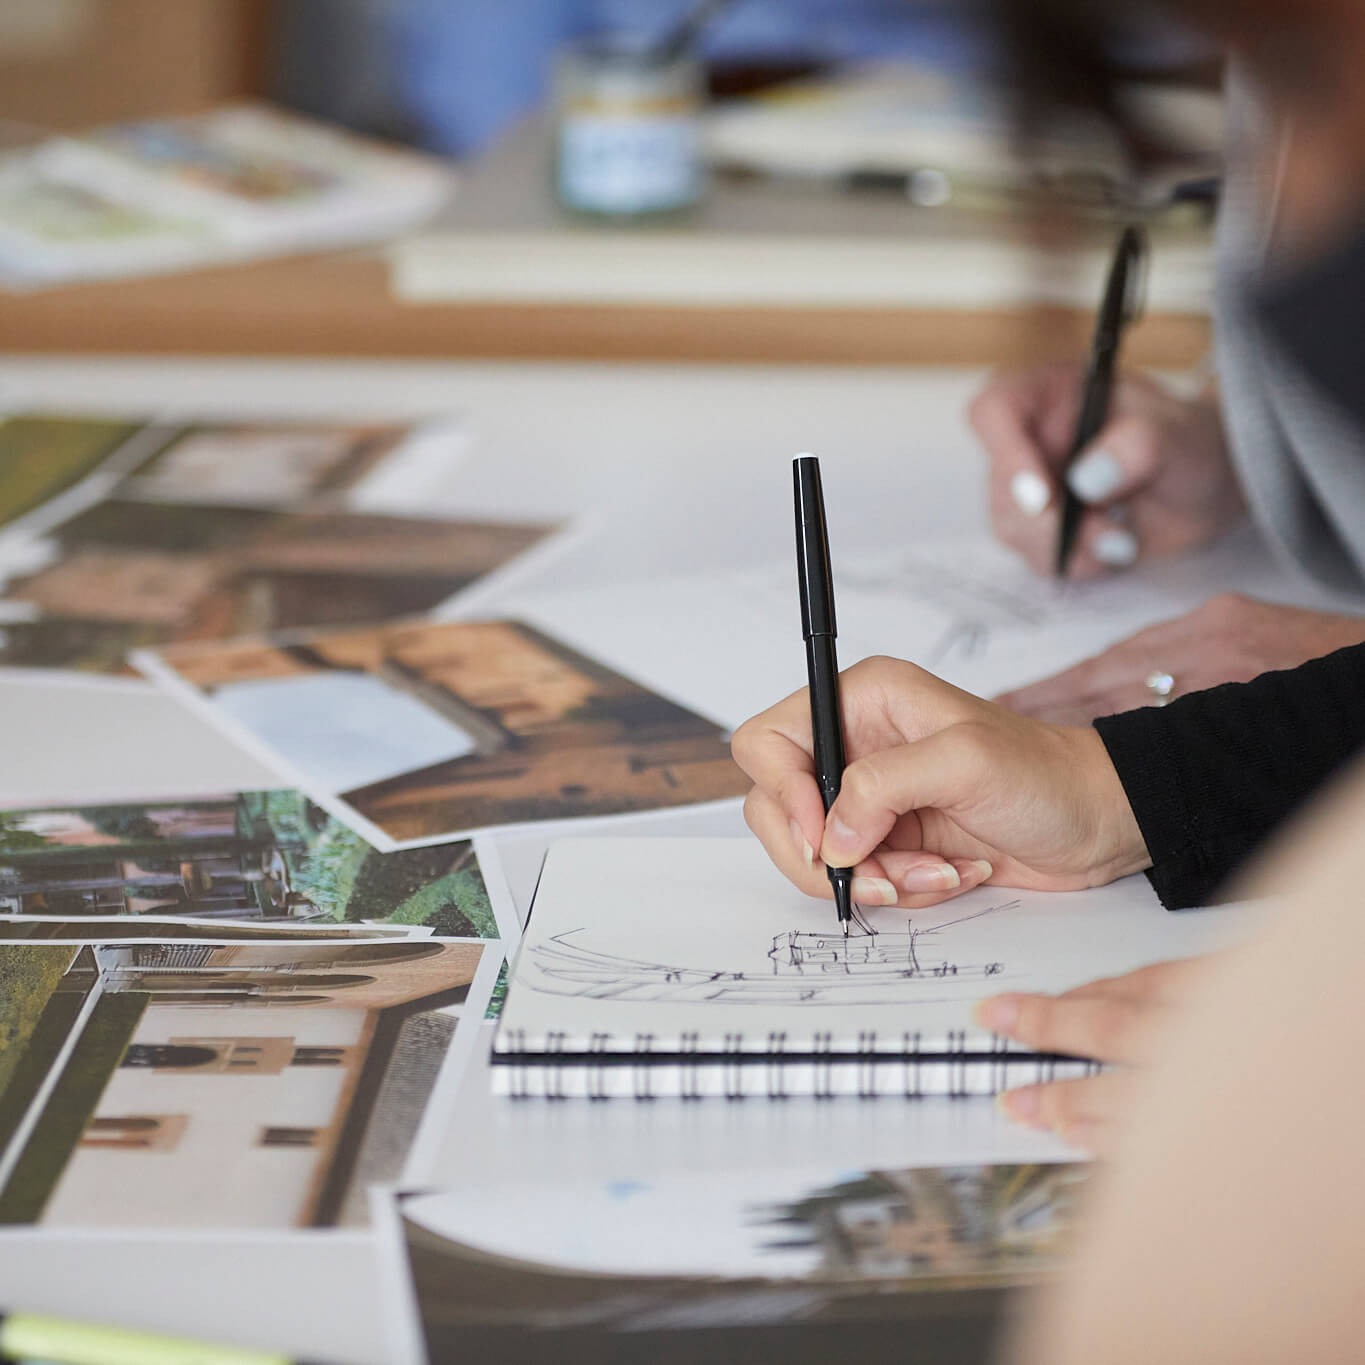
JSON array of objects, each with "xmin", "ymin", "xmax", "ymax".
[{"xmin": 968, "ymin": 366, "xmax": 1244, "ymax": 579}]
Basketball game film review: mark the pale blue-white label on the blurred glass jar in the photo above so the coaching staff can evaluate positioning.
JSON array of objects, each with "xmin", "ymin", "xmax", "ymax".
[{"xmin": 558, "ymin": 115, "xmax": 702, "ymax": 213}]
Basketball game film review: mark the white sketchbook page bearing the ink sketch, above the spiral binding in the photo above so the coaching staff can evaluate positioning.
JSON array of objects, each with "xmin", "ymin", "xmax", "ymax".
[{"xmin": 497, "ymin": 839, "xmax": 1254, "ymax": 1052}]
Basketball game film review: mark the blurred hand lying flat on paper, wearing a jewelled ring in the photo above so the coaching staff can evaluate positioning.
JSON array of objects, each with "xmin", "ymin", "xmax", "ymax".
[{"xmin": 996, "ymin": 592, "xmax": 1365, "ymax": 725}]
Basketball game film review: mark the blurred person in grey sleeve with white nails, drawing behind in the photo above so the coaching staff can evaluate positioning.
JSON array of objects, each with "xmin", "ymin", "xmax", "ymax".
[{"xmin": 971, "ymin": 4, "xmax": 1365, "ymax": 721}]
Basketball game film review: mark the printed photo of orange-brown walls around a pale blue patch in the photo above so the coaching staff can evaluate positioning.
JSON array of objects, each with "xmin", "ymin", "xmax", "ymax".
[{"xmin": 148, "ymin": 621, "xmax": 748, "ymax": 844}]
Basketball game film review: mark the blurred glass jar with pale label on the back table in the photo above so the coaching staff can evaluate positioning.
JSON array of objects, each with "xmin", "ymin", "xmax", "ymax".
[{"xmin": 554, "ymin": 38, "xmax": 706, "ymax": 218}]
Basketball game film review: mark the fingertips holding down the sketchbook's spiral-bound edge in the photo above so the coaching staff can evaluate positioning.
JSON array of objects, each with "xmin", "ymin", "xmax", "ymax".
[{"xmin": 976, "ymin": 956, "xmax": 1218, "ymax": 1155}]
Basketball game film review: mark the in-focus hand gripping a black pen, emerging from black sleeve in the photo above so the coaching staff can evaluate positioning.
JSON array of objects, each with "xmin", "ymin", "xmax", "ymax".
[{"xmin": 733, "ymin": 659, "xmax": 1149, "ymax": 909}]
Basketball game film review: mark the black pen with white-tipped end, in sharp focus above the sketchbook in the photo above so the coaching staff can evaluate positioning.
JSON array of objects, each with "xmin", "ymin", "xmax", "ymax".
[{"xmin": 792, "ymin": 455, "xmax": 853, "ymax": 935}]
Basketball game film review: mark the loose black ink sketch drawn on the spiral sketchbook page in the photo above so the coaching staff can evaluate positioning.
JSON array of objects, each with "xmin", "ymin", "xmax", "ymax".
[{"xmin": 516, "ymin": 901, "xmax": 1020, "ymax": 1005}]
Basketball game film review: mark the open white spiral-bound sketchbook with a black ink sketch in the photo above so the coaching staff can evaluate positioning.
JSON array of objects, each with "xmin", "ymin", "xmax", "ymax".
[{"xmin": 491, "ymin": 838, "xmax": 1253, "ymax": 1099}]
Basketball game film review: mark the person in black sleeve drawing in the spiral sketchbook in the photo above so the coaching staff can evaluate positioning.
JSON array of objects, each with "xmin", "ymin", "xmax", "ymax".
[{"xmin": 734, "ymin": 0, "xmax": 1365, "ymax": 1149}]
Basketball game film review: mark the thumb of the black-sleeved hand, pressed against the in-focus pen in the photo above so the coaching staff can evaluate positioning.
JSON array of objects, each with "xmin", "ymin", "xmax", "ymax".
[{"xmin": 820, "ymin": 721, "xmax": 995, "ymax": 867}]
